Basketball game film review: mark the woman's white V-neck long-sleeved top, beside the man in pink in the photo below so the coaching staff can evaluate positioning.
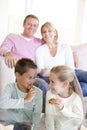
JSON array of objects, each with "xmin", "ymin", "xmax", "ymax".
[{"xmin": 36, "ymin": 43, "xmax": 74, "ymax": 75}]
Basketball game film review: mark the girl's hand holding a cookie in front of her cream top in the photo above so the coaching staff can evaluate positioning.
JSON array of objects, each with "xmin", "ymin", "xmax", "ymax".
[{"xmin": 49, "ymin": 98, "xmax": 64, "ymax": 110}]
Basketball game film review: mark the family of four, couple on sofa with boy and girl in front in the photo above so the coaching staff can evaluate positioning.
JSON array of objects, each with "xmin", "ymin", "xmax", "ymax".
[{"xmin": 0, "ymin": 14, "xmax": 87, "ymax": 130}]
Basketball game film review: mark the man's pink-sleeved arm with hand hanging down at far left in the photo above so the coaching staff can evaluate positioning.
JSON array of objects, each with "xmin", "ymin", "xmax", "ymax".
[{"xmin": 0, "ymin": 34, "xmax": 18, "ymax": 68}]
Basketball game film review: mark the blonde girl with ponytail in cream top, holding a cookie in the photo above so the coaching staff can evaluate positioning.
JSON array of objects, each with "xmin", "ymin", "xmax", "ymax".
[{"xmin": 46, "ymin": 66, "xmax": 84, "ymax": 130}]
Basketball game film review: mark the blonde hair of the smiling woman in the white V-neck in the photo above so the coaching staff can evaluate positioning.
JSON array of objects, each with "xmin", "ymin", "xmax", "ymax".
[{"xmin": 41, "ymin": 22, "xmax": 58, "ymax": 43}]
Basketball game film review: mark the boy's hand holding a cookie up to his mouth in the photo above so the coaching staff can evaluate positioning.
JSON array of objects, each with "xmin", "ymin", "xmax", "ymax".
[{"xmin": 24, "ymin": 86, "xmax": 36, "ymax": 103}]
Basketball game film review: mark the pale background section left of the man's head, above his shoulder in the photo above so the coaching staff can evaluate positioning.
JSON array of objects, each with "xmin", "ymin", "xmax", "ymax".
[{"xmin": 0, "ymin": 0, "xmax": 26, "ymax": 44}]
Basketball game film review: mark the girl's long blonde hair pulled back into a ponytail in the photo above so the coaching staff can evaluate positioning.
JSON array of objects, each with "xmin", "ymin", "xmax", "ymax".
[{"xmin": 50, "ymin": 65, "xmax": 85, "ymax": 113}]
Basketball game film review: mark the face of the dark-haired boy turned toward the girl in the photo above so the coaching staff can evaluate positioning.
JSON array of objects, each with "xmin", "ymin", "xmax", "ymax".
[{"xmin": 16, "ymin": 69, "xmax": 37, "ymax": 92}]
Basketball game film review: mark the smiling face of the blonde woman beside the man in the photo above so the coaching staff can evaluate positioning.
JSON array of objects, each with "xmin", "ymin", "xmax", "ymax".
[{"xmin": 41, "ymin": 26, "xmax": 56, "ymax": 43}]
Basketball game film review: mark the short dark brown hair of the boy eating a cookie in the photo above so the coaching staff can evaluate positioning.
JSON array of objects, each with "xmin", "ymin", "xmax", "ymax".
[{"xmin": 15, "ymin": 58, "xmax": 37, "ymax": 75}]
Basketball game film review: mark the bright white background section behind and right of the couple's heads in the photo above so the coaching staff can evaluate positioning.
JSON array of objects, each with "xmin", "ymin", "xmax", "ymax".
[{"xmin": 27, "ymin": 0, "xmax": 78, "ymax": 44}]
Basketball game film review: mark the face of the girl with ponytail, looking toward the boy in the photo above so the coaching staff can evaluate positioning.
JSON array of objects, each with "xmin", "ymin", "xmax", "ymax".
[{"xmin": 49, "ymin": 72, "xmax": 65, "ymax": 96}]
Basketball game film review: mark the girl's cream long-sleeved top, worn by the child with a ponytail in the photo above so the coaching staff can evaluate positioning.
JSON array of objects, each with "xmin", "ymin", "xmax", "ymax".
[{"xmin": 46, "ymin": 90, "xmax": 83, "ymax": 130}]
